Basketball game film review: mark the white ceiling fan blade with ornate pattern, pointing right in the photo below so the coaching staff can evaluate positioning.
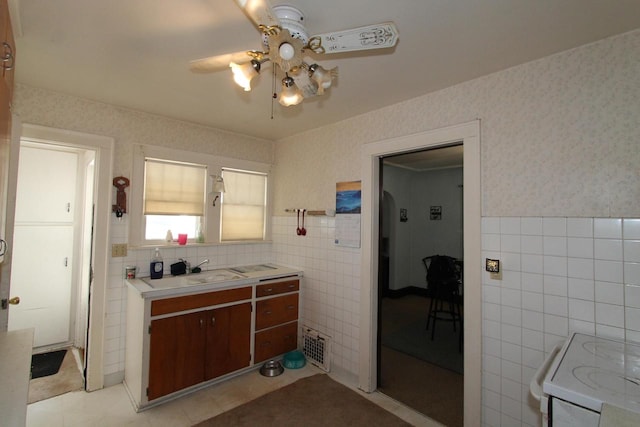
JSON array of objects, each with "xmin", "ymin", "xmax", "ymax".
[{"xmin": 309, "ymin": 22, "xmax": 398, "ymax": 53}]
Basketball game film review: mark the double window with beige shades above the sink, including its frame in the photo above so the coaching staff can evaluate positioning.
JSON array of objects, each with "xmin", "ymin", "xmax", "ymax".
[{"xmin": 129, "ymin": 145, "xmax": 270, "ymax": 247}]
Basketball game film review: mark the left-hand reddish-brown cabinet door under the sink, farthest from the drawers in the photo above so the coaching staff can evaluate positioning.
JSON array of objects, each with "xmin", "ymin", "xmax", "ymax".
[{"xmin": 147, "ymin": 313, "xmax": 206, "ymax": 400}]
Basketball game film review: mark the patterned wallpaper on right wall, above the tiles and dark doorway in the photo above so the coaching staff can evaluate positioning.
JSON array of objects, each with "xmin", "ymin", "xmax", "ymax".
[{"xmin": 275, "ymin": 31, "xmax": 640, "ymax": 217}]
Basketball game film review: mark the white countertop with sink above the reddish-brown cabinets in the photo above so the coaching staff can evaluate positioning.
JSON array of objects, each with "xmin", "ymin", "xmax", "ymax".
[{"xmin": 125, "ymin": 263, "xmax": 302, "ymax": 298}]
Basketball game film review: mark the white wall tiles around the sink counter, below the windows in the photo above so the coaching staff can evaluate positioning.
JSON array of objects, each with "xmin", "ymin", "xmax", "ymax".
[{"xmin": 104, "ymin": 215, "xmax": 360, "ymax": 385}]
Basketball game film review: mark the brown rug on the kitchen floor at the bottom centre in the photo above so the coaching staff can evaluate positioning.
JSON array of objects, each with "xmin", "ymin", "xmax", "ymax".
[{"xmin": 196, "ymin": 374, "xmax": 410, "ymax": 427}]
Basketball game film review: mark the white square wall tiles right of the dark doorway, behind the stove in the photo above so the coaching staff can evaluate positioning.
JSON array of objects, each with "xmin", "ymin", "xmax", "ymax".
[{"xmin": 482, "ymin": 217, "xmax": 640, "ymax": 426}]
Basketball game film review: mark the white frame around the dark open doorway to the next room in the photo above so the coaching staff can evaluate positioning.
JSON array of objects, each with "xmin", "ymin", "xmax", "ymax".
[{"xmin": 358, "ymin": 120, "xmax": 482, "ymax": 425}]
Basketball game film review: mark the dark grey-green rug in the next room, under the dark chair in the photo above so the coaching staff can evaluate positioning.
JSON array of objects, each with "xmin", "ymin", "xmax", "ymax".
[{"xmin": 382, "ymin": 317, "xmax": 464, "ymax": 373}]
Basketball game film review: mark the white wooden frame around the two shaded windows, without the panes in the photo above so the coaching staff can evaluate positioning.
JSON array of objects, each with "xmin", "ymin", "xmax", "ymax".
[{"xmin": 129, "ymin": 144, "xmax": 272, "ymax": 248}]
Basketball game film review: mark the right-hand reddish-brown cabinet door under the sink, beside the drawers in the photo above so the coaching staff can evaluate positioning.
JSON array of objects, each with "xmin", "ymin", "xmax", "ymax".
[{"xmin": 205, "ymin": 303, "xmax": 251, "ymax": 380}]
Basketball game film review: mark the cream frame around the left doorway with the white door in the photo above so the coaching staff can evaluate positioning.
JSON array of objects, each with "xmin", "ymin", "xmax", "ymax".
[{"xmin": 1, "ymin": 122, "xmax": 114, "ymax": 391}]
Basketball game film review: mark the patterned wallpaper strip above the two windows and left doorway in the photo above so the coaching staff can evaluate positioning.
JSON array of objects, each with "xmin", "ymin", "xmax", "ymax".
[{"xmin": 13, "ymin": 84, "xmax": 273, "ymax": 176}]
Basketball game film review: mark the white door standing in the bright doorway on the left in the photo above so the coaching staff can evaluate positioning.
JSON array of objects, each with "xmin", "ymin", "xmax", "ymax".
[{"xmin": 8, "ymin": 145, "xmax": 78, "ymax": 347}]
